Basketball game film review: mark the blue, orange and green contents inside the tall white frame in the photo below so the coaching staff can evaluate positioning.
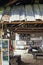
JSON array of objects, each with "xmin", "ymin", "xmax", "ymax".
[{"xmin": 2, "ymin": 40, "xmax": 9, "ymax": 61}]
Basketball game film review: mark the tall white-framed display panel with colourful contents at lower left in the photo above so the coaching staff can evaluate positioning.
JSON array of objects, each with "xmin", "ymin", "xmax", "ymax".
[{"xmin": 0, "ymin": 39, "xmax": 9, "ymax": 65}]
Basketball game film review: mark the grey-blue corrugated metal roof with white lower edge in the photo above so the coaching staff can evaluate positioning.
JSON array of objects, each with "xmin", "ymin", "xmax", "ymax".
[{"xmin": 0, "ymin": 4, "xmax": 43, "ymax": 22}]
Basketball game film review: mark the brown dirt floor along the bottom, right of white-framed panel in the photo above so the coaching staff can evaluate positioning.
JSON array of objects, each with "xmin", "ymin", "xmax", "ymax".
[{"xmin": 10, "ymin": 58, "xmax": 43, "ymax": 65}]
